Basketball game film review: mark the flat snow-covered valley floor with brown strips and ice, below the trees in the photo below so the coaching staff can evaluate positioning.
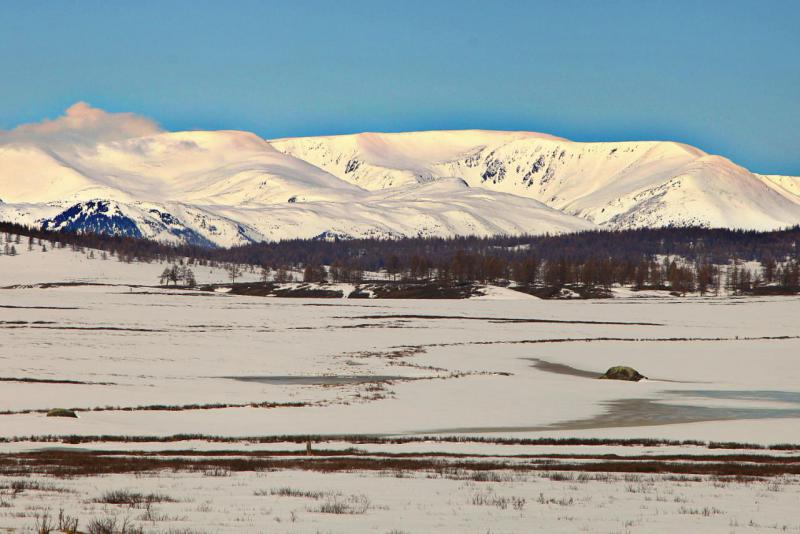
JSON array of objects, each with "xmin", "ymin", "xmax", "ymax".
[{"xmin": 0, "ymin": 266, "xmax": 800, "ymax": 533}]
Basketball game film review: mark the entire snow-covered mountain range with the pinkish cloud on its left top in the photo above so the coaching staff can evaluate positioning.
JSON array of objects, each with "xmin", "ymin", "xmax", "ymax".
[{"xmin": 0, "ymin": 104, "xmax": 800, "ymax": 246}]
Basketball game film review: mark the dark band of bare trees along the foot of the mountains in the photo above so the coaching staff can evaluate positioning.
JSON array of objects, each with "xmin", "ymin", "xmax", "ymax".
[{"xmin": 0, "ymin": 223, "xmax": 800, "ymax": 293}]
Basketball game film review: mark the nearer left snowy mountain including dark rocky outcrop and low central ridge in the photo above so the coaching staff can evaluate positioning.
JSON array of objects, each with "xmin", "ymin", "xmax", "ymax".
[{"xmin": 0, "ymin": 108, "xmax": 594, "ymax": 246}]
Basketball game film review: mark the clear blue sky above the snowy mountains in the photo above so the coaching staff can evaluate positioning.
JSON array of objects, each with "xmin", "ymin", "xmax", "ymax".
[{"xmin": 0, "ymin": 0, "xmax": 800, "ymax": 175}]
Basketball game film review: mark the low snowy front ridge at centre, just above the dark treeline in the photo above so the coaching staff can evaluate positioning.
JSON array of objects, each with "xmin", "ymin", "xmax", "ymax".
[{"xmin": 216, "ymin": 180, "xmax": 594, "ymax": 240}]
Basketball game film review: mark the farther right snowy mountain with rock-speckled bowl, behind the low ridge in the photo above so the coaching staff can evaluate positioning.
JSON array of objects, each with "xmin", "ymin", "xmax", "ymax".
[{"xmin": 272, "ymin": 130, "xmax": 800, "ymax": 229}]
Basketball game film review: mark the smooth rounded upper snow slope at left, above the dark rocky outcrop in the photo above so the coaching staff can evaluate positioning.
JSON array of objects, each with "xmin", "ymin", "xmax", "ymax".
[{"xmin": 0, "ymin": 131, "xmax": 361, "ymax": 205}]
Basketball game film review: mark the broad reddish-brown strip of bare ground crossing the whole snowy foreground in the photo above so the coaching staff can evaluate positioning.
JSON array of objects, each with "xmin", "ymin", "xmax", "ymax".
[{"xmin": 0, "ymin": 450, "xmax": 800, "ymax": 480}]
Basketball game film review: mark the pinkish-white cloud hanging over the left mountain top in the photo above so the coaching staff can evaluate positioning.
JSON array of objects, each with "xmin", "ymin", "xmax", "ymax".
[{"xmin": 0, "ymin": 102, "xmax": 163, "ymax": 146}]
